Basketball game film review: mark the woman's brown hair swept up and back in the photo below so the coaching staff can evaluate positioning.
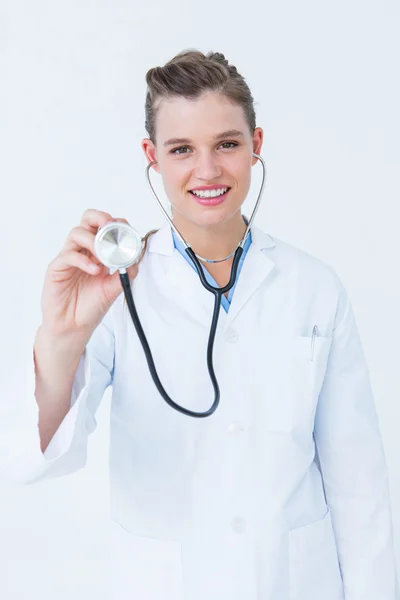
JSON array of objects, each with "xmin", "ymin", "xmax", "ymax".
[{"xmin": 145, "ymin": 50, "xmax": 256, "ymax": 144}]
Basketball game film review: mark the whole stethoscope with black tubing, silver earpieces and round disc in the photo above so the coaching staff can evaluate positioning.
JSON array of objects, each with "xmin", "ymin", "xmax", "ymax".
[{"xmin": 94, "ymin": 153, "xmax": 266, "ymax": 418}]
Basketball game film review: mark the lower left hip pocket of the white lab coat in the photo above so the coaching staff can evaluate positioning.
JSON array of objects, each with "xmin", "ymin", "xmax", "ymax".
[{"xmin": 111, "ymin": 521, "xmax": 184, "ymax": 600}]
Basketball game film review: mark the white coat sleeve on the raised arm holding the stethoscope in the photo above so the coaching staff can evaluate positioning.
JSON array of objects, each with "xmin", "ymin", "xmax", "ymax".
[{"xmin": 0, "ymin": 311, "xmax": 114, "ymax": 483}]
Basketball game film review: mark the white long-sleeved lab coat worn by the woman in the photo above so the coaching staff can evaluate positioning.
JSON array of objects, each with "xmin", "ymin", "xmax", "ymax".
[{"xmin": 4, "ymin": 223, "xmax": 400, "ymax": 600}]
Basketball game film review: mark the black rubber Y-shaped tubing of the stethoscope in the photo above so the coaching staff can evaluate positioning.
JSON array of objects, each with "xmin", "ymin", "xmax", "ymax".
[{"xmin": 120, "ymin": 246, "xmax": 243, "ymax": 418}]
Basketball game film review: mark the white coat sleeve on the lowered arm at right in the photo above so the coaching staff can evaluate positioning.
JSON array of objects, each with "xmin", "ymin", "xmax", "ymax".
[{"xmin": 314, "ymin": 282, "xmax": 400, "ymax": 600}]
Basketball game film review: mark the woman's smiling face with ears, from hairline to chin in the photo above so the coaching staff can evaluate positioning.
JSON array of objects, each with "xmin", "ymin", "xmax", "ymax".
[{"xmin": 142, "ymin": 92, "xmax": 263, "ymax": 226}]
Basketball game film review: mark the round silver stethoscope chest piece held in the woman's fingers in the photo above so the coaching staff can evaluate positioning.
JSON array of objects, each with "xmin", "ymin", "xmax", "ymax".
[{"xmin": 94, "ymin": 221, "xmax": 143, "ymax": 269}]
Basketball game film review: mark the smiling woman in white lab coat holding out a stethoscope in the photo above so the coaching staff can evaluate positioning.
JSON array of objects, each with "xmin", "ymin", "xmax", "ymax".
[{"xmin": 3, "ymin": 51, "xmax": 399, "ymax": 600}]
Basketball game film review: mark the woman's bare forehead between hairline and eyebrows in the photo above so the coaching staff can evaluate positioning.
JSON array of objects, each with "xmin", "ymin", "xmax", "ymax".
[{"xmin": 156, "ymin": 92, "xmax": 248, "ymax": 144}]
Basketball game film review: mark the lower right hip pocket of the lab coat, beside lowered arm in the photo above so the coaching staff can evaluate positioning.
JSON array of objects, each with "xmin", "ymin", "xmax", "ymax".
[{"xmin": 289, "ymin": 509, "xmax": 344, "ymax": 600}]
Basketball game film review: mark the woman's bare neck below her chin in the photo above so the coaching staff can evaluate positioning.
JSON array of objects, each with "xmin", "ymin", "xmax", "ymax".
[{"xmin": 172, "ymin": 212, "xmax": 247, "ymax": 260}]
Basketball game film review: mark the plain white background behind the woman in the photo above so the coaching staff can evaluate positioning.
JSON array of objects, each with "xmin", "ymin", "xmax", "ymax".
[{"xmin": 0, "ymin": 0, "xmax": 400, "ymax": 600}]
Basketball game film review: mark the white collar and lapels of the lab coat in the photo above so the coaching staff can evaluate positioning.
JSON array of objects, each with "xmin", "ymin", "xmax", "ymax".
[{"xmin": 149, "ymin": 222, "xmax": 275, "ymax": 326}]
